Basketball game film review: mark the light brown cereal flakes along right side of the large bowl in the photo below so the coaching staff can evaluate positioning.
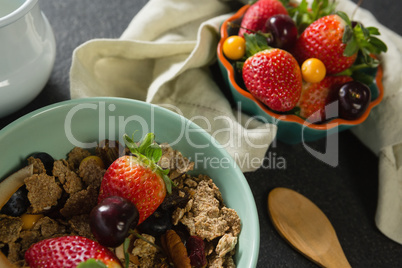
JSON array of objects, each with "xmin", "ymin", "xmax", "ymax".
[{"xmin": 172, "ymin": 175, "xmax": 241, "ymax": 267}]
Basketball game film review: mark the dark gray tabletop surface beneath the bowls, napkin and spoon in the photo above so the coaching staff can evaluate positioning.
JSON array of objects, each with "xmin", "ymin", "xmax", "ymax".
[{"xmin": 0, "ymin": 0, "xmax": 402, "ymax": 267}]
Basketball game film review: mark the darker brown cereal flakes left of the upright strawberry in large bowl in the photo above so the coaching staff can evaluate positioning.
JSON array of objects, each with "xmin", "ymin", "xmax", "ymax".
[{"xmin": 0, "ymin": 148, "xmax": 105, "ymax": 267}]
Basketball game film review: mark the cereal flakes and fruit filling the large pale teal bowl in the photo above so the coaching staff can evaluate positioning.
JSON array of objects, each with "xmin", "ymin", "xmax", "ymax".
[{"xmin": 0, "ymin": 133, "xmax": 241, "ymax": 268}]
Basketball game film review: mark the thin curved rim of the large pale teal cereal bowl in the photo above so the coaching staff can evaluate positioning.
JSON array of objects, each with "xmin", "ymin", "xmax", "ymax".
[{"xmin": 0, "ymin": 97, "xmax": 260, "ymax": 268}]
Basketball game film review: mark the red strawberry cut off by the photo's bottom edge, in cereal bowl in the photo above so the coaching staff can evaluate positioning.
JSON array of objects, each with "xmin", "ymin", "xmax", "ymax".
[{"xmin": 25, "ymin": 236, "xmax": 122, "ymax": 268}]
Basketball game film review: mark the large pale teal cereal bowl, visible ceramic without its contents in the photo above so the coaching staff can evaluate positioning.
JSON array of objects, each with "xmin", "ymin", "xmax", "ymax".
[{"xmin": 0, "ymin": 97, "xmax": 260, "ymax": 268}]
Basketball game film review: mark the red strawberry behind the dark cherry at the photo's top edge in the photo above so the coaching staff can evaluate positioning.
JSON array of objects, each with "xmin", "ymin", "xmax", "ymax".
[{"xmin": 239, "ymin": 0, "xmax": 288, "ymax": 36}]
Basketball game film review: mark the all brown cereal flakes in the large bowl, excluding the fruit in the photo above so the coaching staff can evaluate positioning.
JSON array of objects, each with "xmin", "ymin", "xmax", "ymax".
[{"xmin": 0, "ymin": 143, "xmax": 241, "ymax": 267}]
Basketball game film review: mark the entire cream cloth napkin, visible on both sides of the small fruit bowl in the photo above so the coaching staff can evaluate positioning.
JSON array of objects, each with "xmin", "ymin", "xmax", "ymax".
[{"xmin": 70, "ymin": 0, "xmax": 402, "ymax": 243}]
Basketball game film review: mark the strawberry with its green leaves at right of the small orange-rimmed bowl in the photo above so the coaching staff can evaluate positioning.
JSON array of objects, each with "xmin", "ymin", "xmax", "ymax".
[{"xmin": 292, "ymin": 12, "xmax": 387, "ymax": 74}]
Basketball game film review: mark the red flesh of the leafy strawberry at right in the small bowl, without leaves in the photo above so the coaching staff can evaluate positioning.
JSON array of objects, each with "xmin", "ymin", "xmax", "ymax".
[{"xmin": 292, "ymin": 15, "xmax": 357, "ymax": 74}]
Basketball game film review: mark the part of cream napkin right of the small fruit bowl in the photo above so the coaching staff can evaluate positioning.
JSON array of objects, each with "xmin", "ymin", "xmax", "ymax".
[{"xmin": 338, "ymin": 1, "xmax": 402, "ymax": 244}]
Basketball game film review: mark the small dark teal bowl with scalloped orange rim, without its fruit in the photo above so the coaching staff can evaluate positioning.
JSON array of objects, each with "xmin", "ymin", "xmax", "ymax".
[{"xmin": 217, "ymin": 5, "xmax": 384, "ymax": 144}]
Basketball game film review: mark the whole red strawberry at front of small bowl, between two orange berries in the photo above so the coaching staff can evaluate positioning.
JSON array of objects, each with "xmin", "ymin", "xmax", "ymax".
[{"xmin": 243, "ymin": 41, "xmax": 302, "ymax": 112}]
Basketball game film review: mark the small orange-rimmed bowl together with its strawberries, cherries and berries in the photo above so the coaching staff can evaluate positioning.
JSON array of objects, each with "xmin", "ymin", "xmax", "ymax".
[{"xmin": 217, "ymin": 0, "xmax": 387, "ymax": 143}]
